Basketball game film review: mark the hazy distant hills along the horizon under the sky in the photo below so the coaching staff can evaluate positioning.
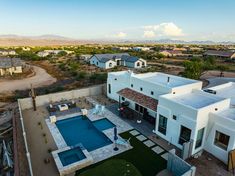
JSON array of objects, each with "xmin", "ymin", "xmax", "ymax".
[{"xmin": 0, "ymin": 35, "xmax": 235, "ymax": 46}]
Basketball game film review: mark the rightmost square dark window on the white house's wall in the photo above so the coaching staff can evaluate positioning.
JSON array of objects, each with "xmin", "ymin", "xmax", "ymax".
[{"xmin": 214, "ymin": 131, "xmax": 230, "ymax": 150}]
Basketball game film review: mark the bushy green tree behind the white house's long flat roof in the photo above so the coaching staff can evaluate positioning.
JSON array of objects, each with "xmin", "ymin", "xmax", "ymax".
[{"xmin": 183, "ymin": 60, "xmax": 203, "ymax": 79}]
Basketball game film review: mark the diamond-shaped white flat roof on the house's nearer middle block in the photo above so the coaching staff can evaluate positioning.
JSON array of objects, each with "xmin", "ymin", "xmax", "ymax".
[{"xmin": 168, "ymin": 90, "xmax": 225, "ymax": 109}]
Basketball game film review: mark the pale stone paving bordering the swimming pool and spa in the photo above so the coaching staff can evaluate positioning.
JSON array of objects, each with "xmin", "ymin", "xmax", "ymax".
[{"xmin": 45, "ymin": 104, "xmax": 133, "ymax": 174}]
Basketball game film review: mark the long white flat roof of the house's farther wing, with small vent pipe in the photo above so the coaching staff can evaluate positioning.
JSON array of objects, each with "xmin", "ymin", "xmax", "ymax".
[{"xmin": 134, "ymin": 72, "xmax": 199, "ymax": 88}]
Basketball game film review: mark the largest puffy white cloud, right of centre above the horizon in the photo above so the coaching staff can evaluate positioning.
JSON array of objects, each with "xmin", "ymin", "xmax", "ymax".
[{"xmin": 143, "ymin": 22, "xmax": 184, "ymax": 37}]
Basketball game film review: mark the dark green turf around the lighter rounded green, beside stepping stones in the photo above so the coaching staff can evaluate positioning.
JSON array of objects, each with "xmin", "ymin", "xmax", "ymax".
[{"xmin": 77, "ymin": 132, "xmax": 167, "ymax": 176}]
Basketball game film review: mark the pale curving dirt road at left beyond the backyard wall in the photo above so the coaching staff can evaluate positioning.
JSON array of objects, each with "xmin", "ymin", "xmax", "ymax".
[{"xmin": 0, "ymin": 66, "xmax": 56, "ymax": 93}]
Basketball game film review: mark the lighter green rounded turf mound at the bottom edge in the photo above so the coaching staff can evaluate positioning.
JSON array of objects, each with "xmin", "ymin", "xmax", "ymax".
[{"xmin": 79, "ymin": 159, "xmax": 142, "ymax": 176}]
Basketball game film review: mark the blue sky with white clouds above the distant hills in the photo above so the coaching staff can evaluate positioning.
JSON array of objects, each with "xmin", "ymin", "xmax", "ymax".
[{"xmin": 0, "ymin": 0, "xmax": 235, "ymax": 41}]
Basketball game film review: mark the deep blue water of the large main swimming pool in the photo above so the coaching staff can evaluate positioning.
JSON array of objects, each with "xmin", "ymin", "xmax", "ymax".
[{"xmin": 56, "ymin": 116, "xmax": 112, "ymax": 151}]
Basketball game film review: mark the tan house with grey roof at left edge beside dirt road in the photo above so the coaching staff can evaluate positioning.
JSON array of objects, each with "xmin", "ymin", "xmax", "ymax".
[{"xmin": 0, "ymin": 58, "xmax": 23, "ymax": 76}]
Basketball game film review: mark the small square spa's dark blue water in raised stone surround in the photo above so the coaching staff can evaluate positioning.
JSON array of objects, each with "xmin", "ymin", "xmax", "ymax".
[{"xmin": 58, "ymin": 147, "xmax": 86, "ymax": 166}]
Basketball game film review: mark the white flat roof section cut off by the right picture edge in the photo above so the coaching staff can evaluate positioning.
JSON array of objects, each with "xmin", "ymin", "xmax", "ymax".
[{"xmin": 208, "ymin": 82, "xmax": 235, "ymax": 105}]
